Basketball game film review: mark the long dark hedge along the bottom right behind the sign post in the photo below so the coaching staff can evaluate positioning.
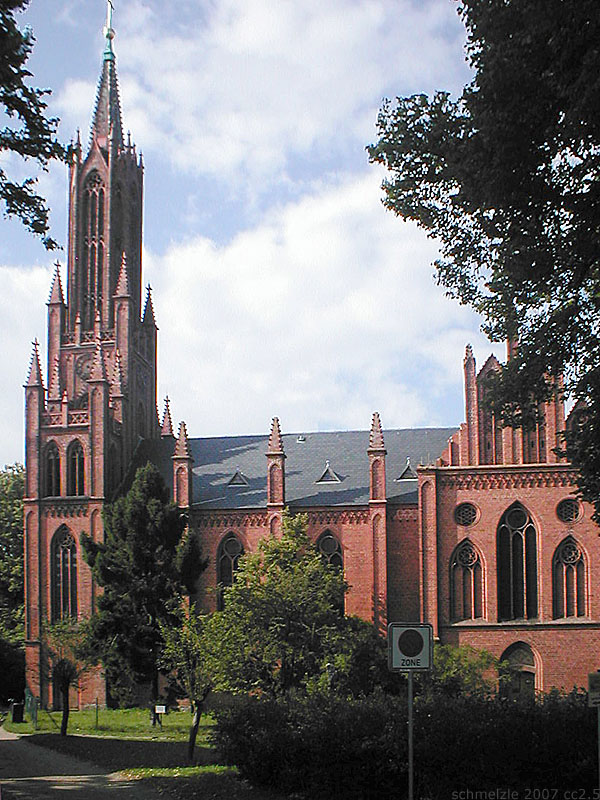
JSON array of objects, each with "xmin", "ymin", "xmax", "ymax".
[{"xmin": 215, "ymin": 692, "xmax": 597, "ymax": 800}]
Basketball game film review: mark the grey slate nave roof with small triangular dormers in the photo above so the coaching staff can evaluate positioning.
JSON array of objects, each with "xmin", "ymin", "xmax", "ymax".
[{"xmin": 134, "ymin": 428, "xmax": 456, "ymax": 510}]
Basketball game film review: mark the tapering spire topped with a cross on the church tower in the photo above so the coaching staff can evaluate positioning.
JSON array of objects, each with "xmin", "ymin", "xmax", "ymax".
[{"xmin": 91, "ymin": 0, "xmax": 123, "ymax": 150}]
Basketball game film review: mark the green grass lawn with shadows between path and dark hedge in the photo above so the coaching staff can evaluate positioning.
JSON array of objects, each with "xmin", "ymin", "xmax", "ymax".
[{"xmin": 4, "ymin": 708, "xmax": 282, "ymax": 800}]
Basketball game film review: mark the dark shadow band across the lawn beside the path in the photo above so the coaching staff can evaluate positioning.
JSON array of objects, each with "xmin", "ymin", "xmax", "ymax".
[{"xmin": 27, "ymin": 733, "xmax": 217, "ymax": 772}]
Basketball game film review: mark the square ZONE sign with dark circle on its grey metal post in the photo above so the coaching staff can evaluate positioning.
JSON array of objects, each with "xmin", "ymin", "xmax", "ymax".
[{"xmin": 388, "ymin": 622, "xmax": 433, "ymax": 800}]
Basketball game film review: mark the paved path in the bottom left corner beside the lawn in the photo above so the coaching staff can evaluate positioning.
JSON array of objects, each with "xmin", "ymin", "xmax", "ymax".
[{"xmin": 0, "ymin": 727, "xmax": 161, "ymax": 800}]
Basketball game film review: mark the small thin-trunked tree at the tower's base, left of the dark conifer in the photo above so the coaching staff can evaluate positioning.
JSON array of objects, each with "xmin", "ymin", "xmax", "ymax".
[{"xmin": 43, "ymin": 618, "xmax": 92, "ymax": 736}]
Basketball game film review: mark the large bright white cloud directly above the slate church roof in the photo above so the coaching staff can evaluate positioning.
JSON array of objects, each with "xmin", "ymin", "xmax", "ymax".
[{"xmin": 145, "ymin": 172, "xmax": 502, "ymax": 436}]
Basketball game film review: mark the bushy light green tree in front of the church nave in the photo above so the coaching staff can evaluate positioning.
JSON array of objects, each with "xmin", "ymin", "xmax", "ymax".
[{"xmin": 205, "ymin": 514, "xmax": 354, "ymax": 696}]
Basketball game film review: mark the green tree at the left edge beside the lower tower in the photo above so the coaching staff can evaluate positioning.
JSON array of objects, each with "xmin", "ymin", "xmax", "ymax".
[{"xmin": 0, "ymin": 464, "xmax": 25, "ymax": 644}]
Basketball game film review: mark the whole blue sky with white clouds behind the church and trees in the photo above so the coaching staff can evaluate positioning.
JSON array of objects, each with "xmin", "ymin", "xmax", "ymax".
[{"xmin": 0, "ymin": 0, "xmax": 503, "ymax": 463}]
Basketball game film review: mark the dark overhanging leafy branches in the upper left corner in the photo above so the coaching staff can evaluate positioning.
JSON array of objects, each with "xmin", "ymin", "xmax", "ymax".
[{"xmin": 0, "ymin": 0, "xmax": 67, "ymax": 250}]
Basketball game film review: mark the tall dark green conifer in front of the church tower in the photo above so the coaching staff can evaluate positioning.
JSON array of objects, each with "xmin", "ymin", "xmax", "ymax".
[{"xmin": 82, "ymin": 464, "xmax": 207, "ymax": 703}]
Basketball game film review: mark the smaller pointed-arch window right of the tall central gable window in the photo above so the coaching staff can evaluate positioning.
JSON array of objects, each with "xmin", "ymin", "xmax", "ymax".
[{"xmin": 552, "ymin": 536, "xmax": 586, "ymax": 619}]
